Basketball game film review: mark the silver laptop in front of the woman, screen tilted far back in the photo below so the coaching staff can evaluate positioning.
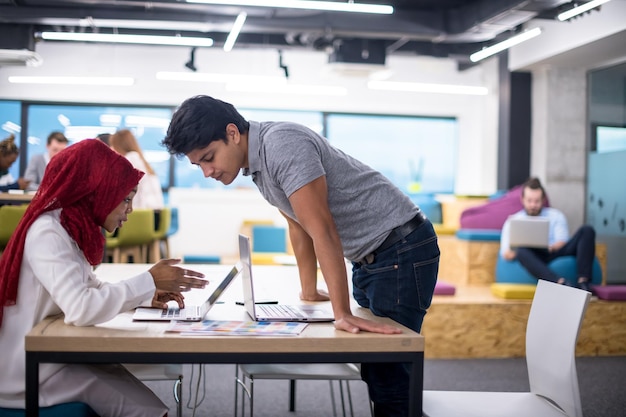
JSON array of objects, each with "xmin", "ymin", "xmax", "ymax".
[{"xmin": 133, "ymin": 264, "xmax": 241, "ymax": 321}]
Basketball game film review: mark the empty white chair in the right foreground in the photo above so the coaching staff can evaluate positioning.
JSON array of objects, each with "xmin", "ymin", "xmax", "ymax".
[{"xmin": 423, "ymin": 280, "xmax": 591, "ymax": 417}]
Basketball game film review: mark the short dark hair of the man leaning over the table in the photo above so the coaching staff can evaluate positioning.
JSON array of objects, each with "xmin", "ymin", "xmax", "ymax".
[{"xmin": 161, "ymin": 96, "xmax": 250, "ymax": 156}]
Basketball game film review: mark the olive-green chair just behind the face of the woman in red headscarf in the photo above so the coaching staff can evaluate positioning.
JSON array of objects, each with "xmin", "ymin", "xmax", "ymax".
[{"xmin": 106, "ymin": 209, "xmax": 155, "ymax": 263}]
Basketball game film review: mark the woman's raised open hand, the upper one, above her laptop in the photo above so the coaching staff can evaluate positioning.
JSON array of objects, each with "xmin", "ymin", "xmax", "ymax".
[{"xmin": 149, "ymin": 259, "xmax": 209, "ymax": 293}]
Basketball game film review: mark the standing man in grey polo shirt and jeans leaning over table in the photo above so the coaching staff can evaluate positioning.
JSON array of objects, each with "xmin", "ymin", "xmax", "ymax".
[{"xmin": 163, "ymin": 96, "xmax": 439, "ymax": 417}]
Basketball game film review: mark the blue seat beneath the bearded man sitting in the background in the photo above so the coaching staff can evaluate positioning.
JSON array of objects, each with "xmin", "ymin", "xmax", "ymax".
[{"xmin": 496, "ymin": 256, "xmax": 602, "ymax": 284}]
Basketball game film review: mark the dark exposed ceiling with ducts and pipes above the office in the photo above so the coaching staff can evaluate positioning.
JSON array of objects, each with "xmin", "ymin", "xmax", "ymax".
[{"xmin": 0, "ymin": 0, "xmax": 596, "ymax": 65}]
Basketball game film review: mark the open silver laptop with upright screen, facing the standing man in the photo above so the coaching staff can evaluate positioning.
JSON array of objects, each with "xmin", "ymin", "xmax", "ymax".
[{"xmin": 239, "ymin": 235, "xmax": 335, "ymax": 322}]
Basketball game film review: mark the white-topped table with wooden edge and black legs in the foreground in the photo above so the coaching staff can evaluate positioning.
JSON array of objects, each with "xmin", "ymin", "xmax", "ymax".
[{"xmin": 25, "ymin": 264, "xmax": 424, "ymax": 417}]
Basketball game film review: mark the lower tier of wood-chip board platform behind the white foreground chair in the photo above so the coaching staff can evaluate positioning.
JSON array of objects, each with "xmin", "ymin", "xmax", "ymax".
[{"xmin": 422, "ymin": 286, "xmax": 626, "ymax": 358}]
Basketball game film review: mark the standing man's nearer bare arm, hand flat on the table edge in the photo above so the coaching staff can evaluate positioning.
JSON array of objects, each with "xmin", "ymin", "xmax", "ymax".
[{"xmin": 289, "ymin": 176, "xmax": 400, "ymax": 333}]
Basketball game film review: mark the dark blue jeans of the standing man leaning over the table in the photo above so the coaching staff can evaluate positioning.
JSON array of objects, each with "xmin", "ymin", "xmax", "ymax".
[{"xmin": 352, "ymin": 220, "xmax": 439, "ymax": 417}]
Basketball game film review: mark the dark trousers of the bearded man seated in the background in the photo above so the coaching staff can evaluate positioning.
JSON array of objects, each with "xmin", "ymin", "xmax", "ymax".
[{"xmin": 516, "ymin": 225, "xmax": 596, "ymax": 282}]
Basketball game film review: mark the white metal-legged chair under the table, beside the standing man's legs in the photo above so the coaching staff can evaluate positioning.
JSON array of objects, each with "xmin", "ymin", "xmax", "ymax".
[{"xmin": 235, "ymin": 363, "xmax": 373, "ymax": 417}]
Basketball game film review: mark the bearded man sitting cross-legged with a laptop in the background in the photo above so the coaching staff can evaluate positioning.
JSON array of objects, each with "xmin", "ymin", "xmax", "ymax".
[{"xmin": 500, "ymin": 178, "xmax": 596, "ymax": 291}]
